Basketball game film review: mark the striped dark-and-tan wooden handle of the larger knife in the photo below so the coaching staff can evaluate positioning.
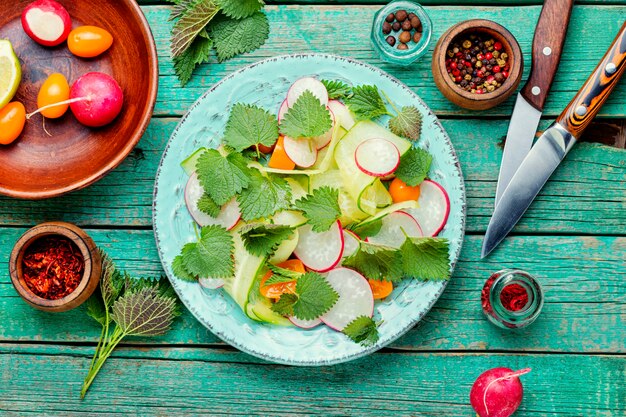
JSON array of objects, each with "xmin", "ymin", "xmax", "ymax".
[{"xmin": 556, "ymin": 22, "xmax": 626, "ymax": 139}]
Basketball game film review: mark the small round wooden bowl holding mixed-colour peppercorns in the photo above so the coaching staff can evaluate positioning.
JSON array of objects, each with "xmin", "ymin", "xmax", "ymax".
[{"xmin": 432, "ymin": 19, "xmax": 524, "ymax": 110}]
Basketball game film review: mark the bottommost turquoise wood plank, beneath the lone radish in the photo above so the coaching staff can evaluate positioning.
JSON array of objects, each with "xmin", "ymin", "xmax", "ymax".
[{"xmin": 0, "ymin": 345, "xmax": 626, "ymax": 417}]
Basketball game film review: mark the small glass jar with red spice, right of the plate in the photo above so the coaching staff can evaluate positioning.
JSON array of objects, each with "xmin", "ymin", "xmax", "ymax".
[{"xmin": 481, "ymin": 269, "xmax": 543, "ymax": 329}]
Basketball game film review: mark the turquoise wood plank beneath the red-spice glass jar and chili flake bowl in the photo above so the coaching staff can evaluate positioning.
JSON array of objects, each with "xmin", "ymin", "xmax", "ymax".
[{"xmin": 0, "ymin": 229, "xmax": 626, "ymax": 353}]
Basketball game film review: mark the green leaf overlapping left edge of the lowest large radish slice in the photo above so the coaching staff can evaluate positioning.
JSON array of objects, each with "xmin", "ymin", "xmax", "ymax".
[{"xmin": 292, "ymin": 272, "xmax": 339, "ymax": 320}]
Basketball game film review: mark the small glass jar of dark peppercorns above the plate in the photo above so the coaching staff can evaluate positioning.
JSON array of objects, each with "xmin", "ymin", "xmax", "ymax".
[{"xmin": 370, "ymin": 0, "xmax": 433, "ymax": 65}]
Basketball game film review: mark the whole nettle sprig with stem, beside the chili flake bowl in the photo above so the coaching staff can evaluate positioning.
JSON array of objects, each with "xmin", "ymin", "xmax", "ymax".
[{"xmin": 80, "ymin": 251, "xmax": 180, "ymax": 398}]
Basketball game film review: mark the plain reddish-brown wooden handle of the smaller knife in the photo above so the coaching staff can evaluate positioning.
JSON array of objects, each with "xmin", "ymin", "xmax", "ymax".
[{"xmin": 520, "ymin": 0, "xmax": 574, "ymax": 111}]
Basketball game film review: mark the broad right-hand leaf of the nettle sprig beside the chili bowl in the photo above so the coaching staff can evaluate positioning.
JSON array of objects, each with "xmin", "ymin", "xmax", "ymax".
[{"xmin": 112, "ymin": 284, "xmax": 179, "ymax": 336}]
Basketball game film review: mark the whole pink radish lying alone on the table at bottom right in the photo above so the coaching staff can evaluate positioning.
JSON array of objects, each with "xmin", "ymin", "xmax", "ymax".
[{"xmin": 470, "ymin": 368, "xmax": 530, "ymax": 417}]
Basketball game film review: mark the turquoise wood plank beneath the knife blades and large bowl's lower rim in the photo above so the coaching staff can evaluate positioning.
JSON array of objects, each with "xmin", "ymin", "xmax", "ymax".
[{"xmin": 0, "ymin": 118, "xmax": 626, "ymax": 234}]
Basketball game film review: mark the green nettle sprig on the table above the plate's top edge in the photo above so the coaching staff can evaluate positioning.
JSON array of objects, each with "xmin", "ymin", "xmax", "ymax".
[{"xmin": 167, "ymin": 0, "xmax": 270, "ymax": 86}]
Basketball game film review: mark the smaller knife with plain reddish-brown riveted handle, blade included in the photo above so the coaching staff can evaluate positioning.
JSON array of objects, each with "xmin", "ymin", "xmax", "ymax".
[{"xmin": 495, "ymin": 0, "xmax": 574, "ymax": 206}]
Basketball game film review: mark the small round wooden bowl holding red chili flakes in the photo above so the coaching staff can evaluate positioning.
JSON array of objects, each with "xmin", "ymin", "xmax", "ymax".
[{"xmin": 9, "ymin": 222, "xmax": 102, "ymax": 313}]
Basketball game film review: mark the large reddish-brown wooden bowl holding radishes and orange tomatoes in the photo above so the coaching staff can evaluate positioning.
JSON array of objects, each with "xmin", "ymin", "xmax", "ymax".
[{"xmin": 0, "ymin": 0, "xmax": 158, "ymax": 199}]
